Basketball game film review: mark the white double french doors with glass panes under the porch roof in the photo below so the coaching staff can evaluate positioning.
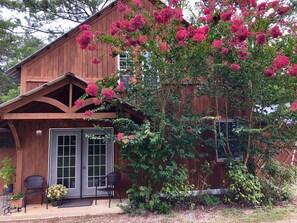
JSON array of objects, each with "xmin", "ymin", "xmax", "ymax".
[{"xmin": 48, "ymin": 128, "xmax": 113, "ymax": 198}]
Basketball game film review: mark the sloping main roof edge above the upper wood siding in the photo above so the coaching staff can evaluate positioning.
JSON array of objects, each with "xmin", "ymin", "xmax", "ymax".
[{"xmin": 5, "ymin": 0, "xmax": 164, "ymax": 82}]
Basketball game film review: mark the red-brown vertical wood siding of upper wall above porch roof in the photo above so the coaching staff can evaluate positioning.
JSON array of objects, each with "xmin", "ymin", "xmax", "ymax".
[{"xmin": 21, "ymin": 2, "xmax": 143, "ymax": 93}]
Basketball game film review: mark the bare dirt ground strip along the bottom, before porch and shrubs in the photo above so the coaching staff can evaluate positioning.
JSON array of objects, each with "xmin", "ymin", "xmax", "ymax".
[{"xmin": 4, "ymin": 198, "xmax": 297, "ymax": 223}]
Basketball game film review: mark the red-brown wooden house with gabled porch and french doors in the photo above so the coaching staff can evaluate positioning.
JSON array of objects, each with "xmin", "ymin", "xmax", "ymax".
[{"xmin": 0, "ymin": 0, "xmax": 294, "ymax": 198}]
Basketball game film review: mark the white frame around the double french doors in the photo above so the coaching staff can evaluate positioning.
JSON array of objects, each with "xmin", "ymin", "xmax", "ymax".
[{"xmin": 47, "ymin": 127, "xmax": 114, "ymax": 199}]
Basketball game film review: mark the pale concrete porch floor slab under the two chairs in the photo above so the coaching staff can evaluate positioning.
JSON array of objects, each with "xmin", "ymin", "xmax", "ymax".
[{"xmin": 0, "ymin": 199, "xmax": 127, "ymax": 222}]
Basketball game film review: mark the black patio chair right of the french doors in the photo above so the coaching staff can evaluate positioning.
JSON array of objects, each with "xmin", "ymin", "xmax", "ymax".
[{"xmin": 95, "ymin": 172, "xmax": 122, "ymax": 207}]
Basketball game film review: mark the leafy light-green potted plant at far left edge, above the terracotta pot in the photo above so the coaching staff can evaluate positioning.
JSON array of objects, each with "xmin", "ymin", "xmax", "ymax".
[{"xmin": 0, "ymin": 157, "xmax": 16, "ymax": 193}]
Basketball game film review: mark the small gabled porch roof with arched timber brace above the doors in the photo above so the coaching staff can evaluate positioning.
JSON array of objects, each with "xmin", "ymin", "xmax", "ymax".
[{"xmin": 0, "ymin": 72, "xmax": 143, "ymax": 123}]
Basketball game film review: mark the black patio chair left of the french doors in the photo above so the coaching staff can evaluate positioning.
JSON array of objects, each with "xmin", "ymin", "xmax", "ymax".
[{"xmin": 24, "ymin": 175, "xmax": 48, "ymax": 213}]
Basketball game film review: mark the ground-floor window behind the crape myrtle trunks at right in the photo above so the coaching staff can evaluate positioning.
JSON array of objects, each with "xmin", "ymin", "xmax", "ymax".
[{"xmin": 215, "ymin": 119, "xmax": 241, "ymax": 162}]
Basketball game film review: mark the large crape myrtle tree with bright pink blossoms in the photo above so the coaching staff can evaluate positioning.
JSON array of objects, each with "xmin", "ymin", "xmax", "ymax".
[{"xmin": 76, "ymin": 0, "xmax": 297, "ymax": 208}]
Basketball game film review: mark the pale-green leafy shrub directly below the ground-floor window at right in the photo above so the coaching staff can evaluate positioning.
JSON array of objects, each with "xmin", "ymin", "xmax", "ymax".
[{"xmin": 225, "ymin": 162, "xmax": 263, "ymax": 206}]
